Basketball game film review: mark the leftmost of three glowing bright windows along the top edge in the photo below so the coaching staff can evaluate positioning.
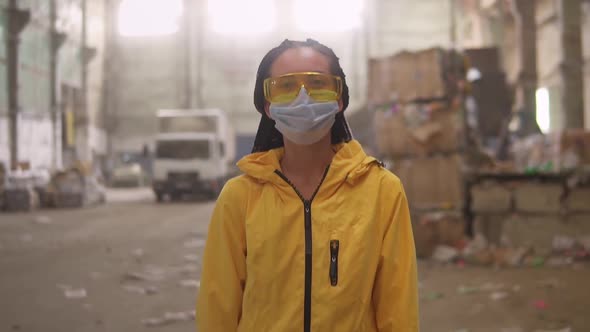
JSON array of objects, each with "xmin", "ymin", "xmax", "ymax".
[{"xmin": 118, "ymin": 0, "xmax": 183, "ymax": 37}]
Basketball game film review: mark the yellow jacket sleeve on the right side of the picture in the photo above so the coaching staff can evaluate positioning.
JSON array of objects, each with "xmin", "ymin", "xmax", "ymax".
[{"xmin": 373, "ymin": 184, "xmax": 419, "ymax": 332}]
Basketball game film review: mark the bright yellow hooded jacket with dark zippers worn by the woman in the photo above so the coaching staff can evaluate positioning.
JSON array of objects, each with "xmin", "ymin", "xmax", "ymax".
[{"xmin": 197, "ymin": 141, "xmax": 419, "ymax": 332}]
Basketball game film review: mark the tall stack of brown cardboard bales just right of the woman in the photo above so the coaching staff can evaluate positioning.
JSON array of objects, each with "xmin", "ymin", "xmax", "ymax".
[{"xmin": 369, "ymin": 48, "xmax": 466, "ymax": 210}]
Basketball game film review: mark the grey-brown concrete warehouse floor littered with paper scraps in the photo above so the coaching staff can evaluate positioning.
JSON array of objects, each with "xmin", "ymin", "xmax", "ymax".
[{"xmin": 0, "ymin": 189, "xmax": 590, "ymax": 332}]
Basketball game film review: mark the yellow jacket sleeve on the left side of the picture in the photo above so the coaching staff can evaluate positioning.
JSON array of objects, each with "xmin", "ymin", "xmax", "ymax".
[{"xmin": 196, "ymin": 180, "xmax": 247, "ymax": 332}]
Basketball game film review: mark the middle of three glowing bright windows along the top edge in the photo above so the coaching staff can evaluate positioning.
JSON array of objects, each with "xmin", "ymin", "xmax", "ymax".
[{"xmin": 207, "ymin": 0, "xmax": 276, "ymax": 35}]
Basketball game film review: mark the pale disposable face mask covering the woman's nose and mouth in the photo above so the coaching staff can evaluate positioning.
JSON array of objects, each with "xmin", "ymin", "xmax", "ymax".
[{"xmin": 269, "ymin": 88, "xmax": 340, "ymax": 145}]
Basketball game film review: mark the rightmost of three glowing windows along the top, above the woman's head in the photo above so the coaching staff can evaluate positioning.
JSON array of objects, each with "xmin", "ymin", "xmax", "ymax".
[{"xmin": 293, "ymin": 0, "xmax": 364, "ymax": 32}]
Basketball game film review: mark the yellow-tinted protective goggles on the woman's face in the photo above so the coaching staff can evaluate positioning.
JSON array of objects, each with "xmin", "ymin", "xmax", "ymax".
[{"xmin": 264, "ymin": 72, "xmax": 342, "ymax": 104}]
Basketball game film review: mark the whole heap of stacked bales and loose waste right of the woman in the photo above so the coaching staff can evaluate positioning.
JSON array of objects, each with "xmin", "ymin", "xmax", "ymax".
[{"xmin": 368, "ymin": 48, "xmax": 590, "ymax": 257}]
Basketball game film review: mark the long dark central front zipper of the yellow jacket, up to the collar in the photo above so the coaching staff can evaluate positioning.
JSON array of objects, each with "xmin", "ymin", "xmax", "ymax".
[{"xmin": 275, "ymin": 165, "xmax": 330, "ymax": 332}]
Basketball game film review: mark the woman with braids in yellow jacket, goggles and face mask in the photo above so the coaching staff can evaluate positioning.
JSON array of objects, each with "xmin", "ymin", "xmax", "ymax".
[{"xmin": 197, "ymin": 39, "xmax": 419, "ymax": 332}]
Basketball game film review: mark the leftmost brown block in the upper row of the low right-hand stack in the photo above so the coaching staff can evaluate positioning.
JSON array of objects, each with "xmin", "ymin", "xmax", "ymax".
[{"xmin": 471, "ymin": 182, "xmax": 512, "ymax": 214}]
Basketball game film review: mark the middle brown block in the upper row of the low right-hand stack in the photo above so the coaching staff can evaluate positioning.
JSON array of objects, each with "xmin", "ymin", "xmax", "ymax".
[{"xmin": 514, "ymin": 183, "xmax": 564, "ymax": 214}]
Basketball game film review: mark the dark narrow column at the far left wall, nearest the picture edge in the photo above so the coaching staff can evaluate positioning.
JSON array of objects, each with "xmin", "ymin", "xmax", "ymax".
[{"xmin": 4, "ymin": 0, "xmax": 31, "ymax": 168}]
